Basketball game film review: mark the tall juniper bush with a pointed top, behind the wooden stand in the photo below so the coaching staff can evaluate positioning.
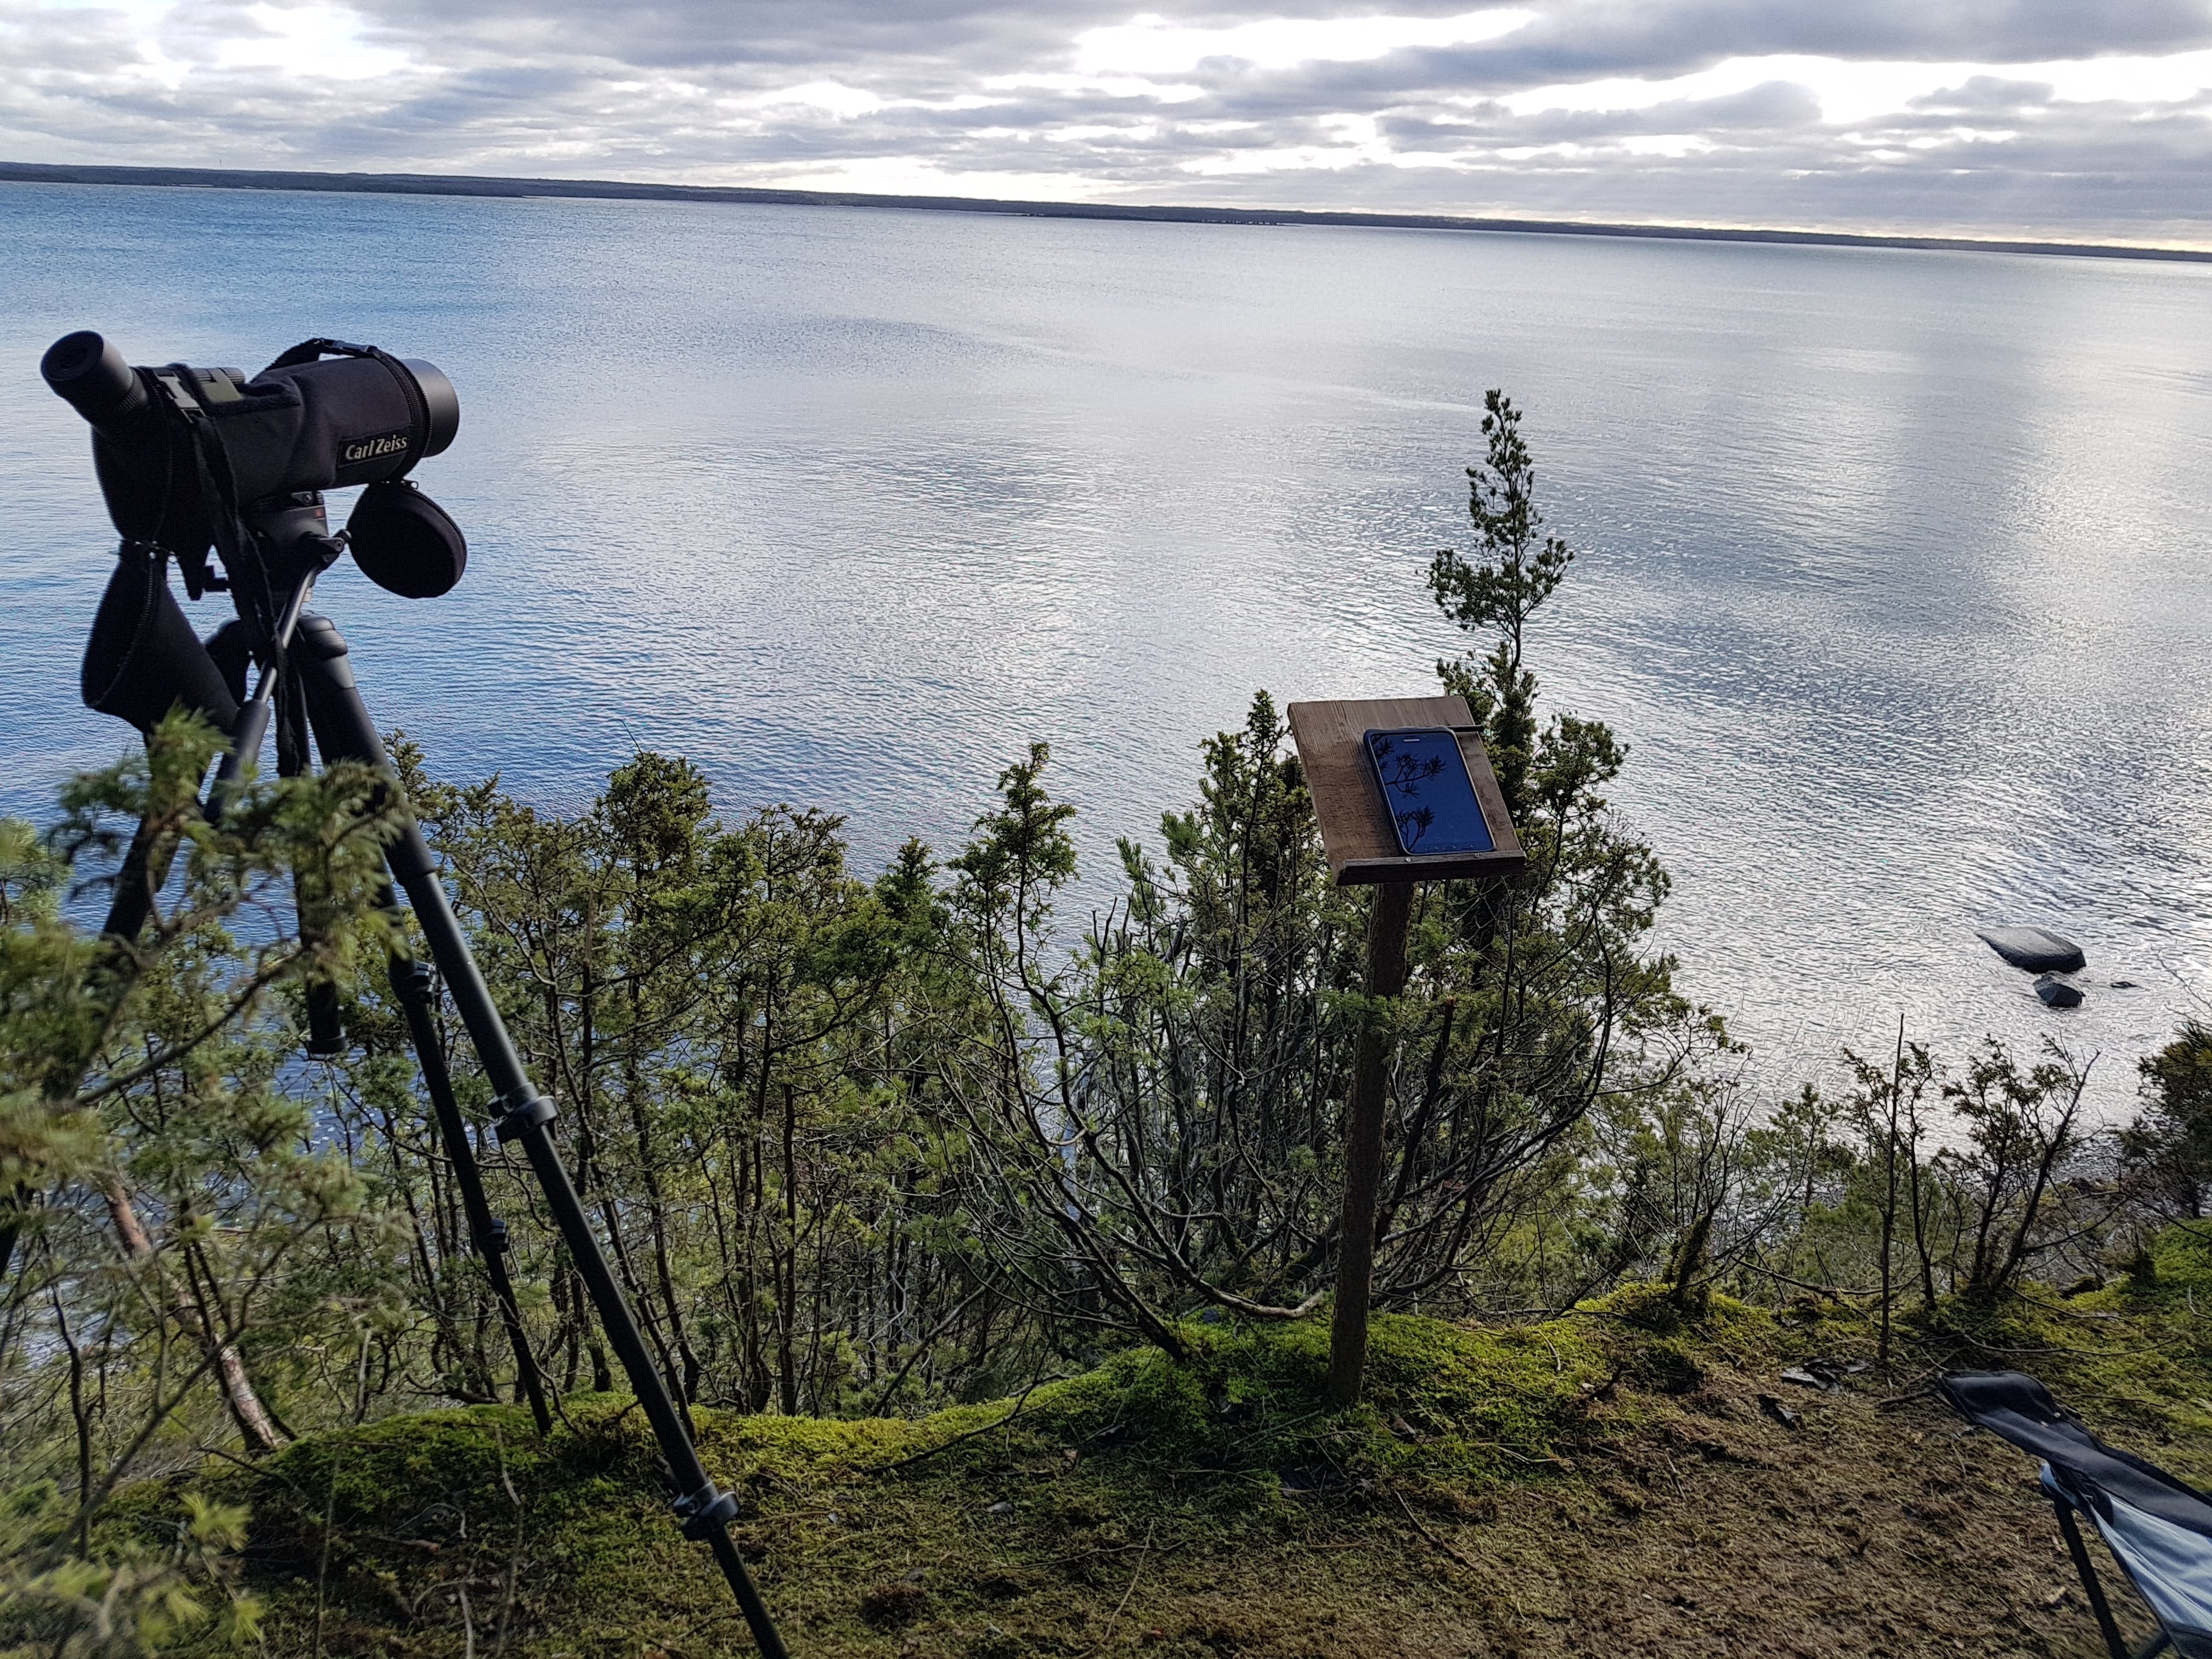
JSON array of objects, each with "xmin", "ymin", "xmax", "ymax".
[{"xmin": 947, "ymin": 394, "xmax": 1699, "ymax": 1352}]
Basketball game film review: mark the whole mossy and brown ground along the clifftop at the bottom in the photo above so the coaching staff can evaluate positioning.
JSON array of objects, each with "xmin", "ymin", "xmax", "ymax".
[{"xmin": 131, "ymin": 1232, "xmax": 2212, "ymax": 1659}]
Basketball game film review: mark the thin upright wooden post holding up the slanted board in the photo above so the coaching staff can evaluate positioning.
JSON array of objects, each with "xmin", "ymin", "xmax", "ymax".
[{"xmin": 1329, "ymin": 881, "xmax": 1413, "ymax": 1407}]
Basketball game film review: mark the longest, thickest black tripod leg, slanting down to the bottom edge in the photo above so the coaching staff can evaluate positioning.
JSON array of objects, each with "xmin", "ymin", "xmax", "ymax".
[{"xmin": 294, "ymin": 617, "xmax": 789, "ymax": 1659}]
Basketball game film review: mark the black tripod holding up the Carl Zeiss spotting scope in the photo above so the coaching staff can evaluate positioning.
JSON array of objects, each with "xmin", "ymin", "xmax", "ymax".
[{"xmin": 109, "ymin": 513, "xmax": 787, "ymax": 1659}]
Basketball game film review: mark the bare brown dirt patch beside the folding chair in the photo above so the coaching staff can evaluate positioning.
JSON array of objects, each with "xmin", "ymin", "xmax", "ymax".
[{"xmin": 1398, "ymin": 1378, "xmax": 2148, "ymax": 1659}]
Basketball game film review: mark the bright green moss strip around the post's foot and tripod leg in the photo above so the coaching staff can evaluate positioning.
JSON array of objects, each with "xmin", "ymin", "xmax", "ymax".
[{"xmin": 163, "ymin": 1316, "xmax": 1628, "ymax": 1652}]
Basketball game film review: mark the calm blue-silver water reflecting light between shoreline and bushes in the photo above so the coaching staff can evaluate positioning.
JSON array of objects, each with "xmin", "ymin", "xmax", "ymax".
[{"xmin": 0, "ymin": 184, "xmax": 2212, "ymax": 1121}]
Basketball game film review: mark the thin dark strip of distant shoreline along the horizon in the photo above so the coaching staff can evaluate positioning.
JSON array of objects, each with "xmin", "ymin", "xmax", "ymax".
[{"xmin": 0, "ymin": 161, "xmax": 2212, "ymax": 263}]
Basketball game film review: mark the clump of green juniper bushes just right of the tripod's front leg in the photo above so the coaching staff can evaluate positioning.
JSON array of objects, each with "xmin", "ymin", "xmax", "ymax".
[{"xmin": 374, "ymin": 741, "xmax": 986, "ymax": 1413}]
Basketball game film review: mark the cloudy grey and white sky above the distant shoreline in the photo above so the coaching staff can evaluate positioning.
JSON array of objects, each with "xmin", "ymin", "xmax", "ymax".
[{"xmin": 0, "ymin": 0, "xmax": 2212, "ymax": 248}]
